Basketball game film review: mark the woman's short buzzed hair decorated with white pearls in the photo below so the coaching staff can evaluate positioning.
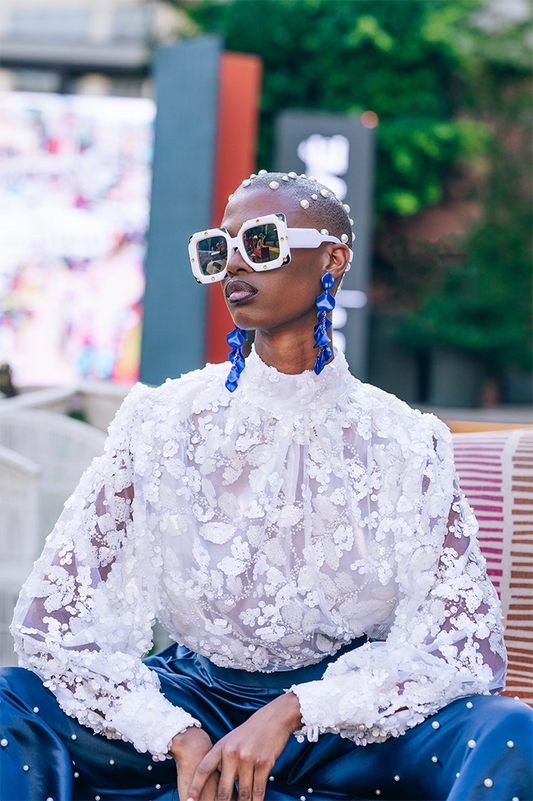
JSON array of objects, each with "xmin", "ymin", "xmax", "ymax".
[{"xmin": 230, "ymin": 171, "xmax": 353, "ymax": 242}]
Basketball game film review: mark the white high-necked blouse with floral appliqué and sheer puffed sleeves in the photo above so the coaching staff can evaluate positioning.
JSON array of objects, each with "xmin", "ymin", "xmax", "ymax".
[{"xmin": 12, "ymin": 352, "xmax": 505, "ymax": 758}]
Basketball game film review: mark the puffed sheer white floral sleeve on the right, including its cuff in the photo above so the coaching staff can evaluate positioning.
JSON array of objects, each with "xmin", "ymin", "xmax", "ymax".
[{"xmin": 291, "ymin": 415, "xmax": 505, "ymax": 745}]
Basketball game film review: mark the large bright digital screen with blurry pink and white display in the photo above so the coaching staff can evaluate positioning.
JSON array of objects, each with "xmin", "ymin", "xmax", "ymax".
[{"xmin": 0, "ymin": 92, "xmax": 155, "ymax": 386}]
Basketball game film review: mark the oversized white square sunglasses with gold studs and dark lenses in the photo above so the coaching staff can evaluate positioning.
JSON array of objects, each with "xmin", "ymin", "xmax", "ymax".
[{"xmin": 189, "ymin": 213, "xmax": 353, "ymax": 284}]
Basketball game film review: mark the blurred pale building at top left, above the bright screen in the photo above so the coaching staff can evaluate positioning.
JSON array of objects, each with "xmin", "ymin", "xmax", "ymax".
[{"xmin": 0, "ymin": 0, "xmax": 185, "ymax": 97}]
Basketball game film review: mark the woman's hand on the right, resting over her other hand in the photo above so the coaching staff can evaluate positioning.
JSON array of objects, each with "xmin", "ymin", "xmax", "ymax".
[{"xmin": 184, "ymin": 693, "xmax": 301, "ymax": 801}]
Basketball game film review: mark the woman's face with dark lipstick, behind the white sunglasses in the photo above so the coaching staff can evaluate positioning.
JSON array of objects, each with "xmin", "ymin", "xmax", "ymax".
[{"xmin": 221, "ymin": 187, "xmax": 347, "ymax": 331}]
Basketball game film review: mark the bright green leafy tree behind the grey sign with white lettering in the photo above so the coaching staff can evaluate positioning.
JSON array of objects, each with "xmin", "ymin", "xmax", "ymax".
[{"xmin": 179, "ymin": 0, "xmax": 485, "ymax": 214}]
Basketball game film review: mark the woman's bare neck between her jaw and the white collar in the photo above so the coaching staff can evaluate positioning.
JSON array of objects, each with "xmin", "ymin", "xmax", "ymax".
[{"xmin": 251, "ymin": 313, "xmax": 330, "ymax": 375}]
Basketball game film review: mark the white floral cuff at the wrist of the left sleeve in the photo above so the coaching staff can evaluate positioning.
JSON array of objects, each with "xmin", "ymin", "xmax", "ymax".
[{"xmin": 103, "ymin": 687, "xmax": 201, "ymax": 760}]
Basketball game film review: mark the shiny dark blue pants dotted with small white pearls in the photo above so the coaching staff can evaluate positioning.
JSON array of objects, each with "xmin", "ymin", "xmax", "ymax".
[{"xmin": 0, "ymin": 646, "xmax": 533, "ymax": 801}]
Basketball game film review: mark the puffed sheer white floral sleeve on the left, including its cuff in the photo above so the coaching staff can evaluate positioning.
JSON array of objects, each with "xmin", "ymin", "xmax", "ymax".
[{"xmin": 11, "ymin": 385, "xmax": 199, "ymax": 759}]
